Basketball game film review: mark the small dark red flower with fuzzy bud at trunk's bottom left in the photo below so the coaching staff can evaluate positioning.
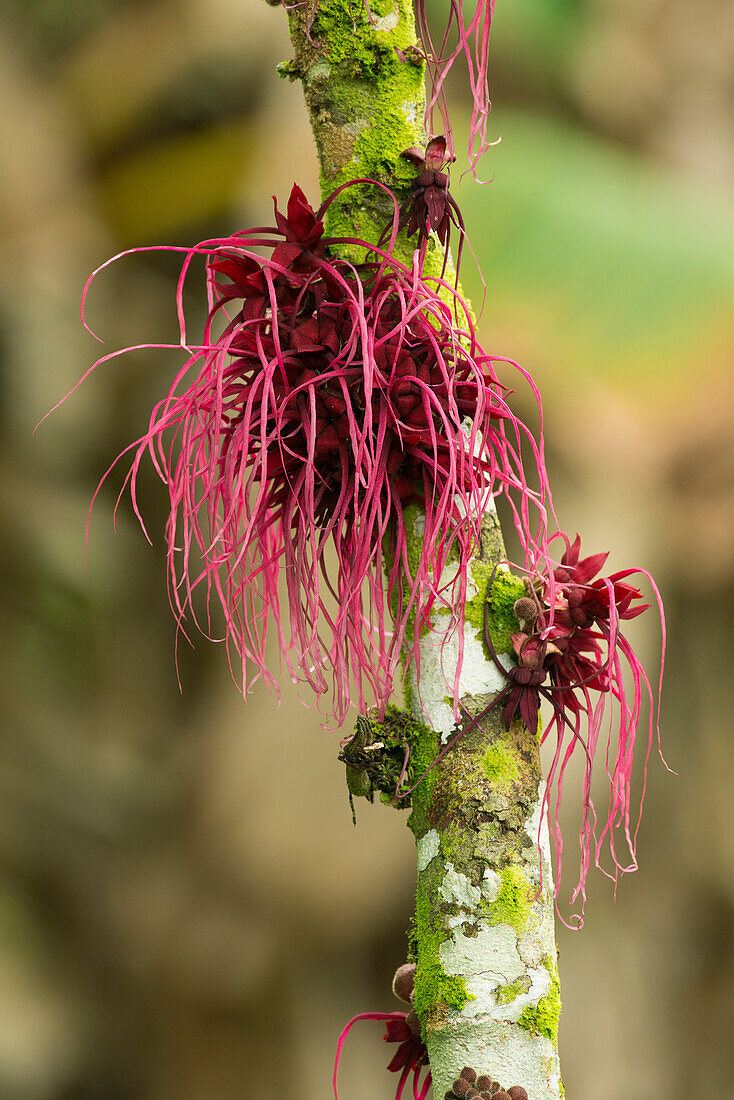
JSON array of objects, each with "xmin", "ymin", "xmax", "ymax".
[{"xmin": 332, "ymin": 963, "xmax": 431, "ymax": 1100}]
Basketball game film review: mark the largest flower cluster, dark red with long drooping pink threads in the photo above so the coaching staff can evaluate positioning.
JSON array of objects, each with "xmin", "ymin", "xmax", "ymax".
[{"xmin": 70, "ymin": 185, "xmax": 548, "ymax": 722}]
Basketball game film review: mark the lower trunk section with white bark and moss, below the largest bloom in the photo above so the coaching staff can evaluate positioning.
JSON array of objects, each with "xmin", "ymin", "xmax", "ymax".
[{"xmin": 408, "ymin": 512, "xmax": 562, "ymax": 1100}]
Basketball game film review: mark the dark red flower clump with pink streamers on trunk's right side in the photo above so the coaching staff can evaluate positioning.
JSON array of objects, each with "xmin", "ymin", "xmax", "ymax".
[{"xmin": 461, "ymin": 532, "xmax": 665, "ymax": 909}]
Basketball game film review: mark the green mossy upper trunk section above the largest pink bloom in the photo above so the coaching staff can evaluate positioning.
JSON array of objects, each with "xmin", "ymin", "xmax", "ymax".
[{"xmin": 282, "ymin": 0, "xmax": 425, "ymax": 249}]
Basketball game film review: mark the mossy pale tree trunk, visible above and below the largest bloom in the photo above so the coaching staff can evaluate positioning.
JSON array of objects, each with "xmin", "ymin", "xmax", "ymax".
[{"xmin": 282, "ymin": 0, "xmax": 562, "ymax": 1100}]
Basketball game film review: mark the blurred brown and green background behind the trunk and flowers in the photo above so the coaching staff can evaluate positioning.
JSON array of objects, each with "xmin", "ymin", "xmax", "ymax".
[{"xmin": 0, "ymin": 0, "xmax": 734, "ymax": 1100}]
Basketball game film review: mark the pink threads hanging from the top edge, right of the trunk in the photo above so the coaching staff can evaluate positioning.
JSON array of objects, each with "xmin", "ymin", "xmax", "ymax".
[{"xmin": 416, "ymin": 0, "xmax": 494, "ymax": 175}]
